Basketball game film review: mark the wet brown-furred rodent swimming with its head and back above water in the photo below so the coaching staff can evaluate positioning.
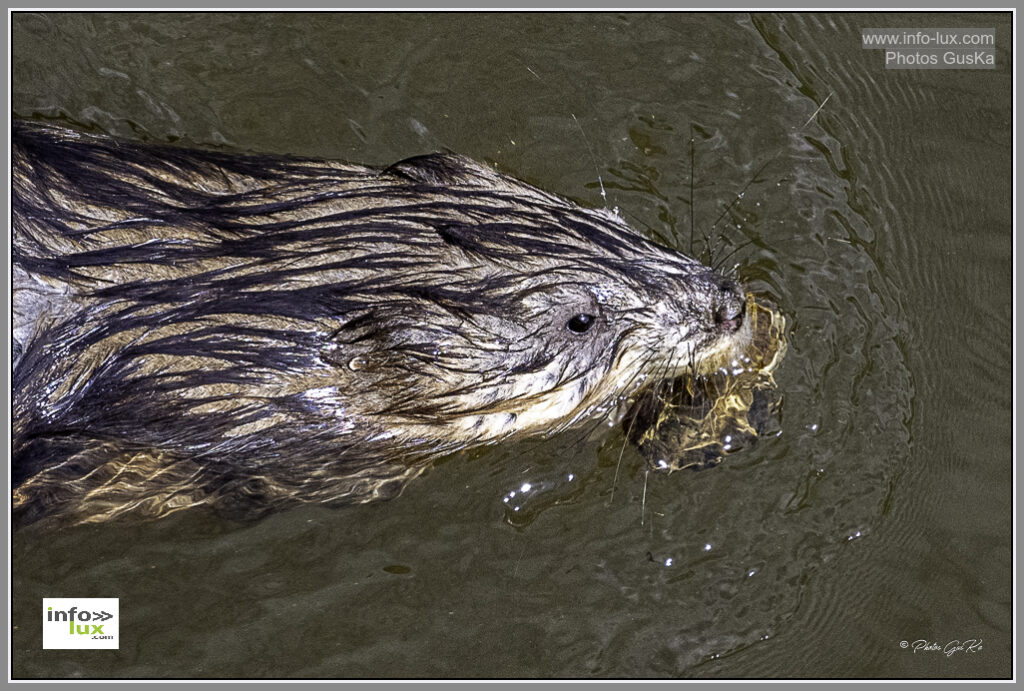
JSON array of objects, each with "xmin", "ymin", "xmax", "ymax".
[{"xmin": 11, "ymin": 122, "xmax": 750, "ymax": 522}]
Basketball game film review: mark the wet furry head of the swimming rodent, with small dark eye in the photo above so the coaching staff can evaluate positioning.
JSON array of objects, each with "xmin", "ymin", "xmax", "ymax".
[{"xmin": 307, "ymin": 156, "xmax": 745, "ymax": 443}]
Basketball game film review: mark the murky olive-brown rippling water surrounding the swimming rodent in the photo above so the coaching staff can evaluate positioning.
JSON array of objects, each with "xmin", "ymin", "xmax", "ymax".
[{"xmin": 12, "ymin": 13, "xmax": 1013, "ymax": 678}]
